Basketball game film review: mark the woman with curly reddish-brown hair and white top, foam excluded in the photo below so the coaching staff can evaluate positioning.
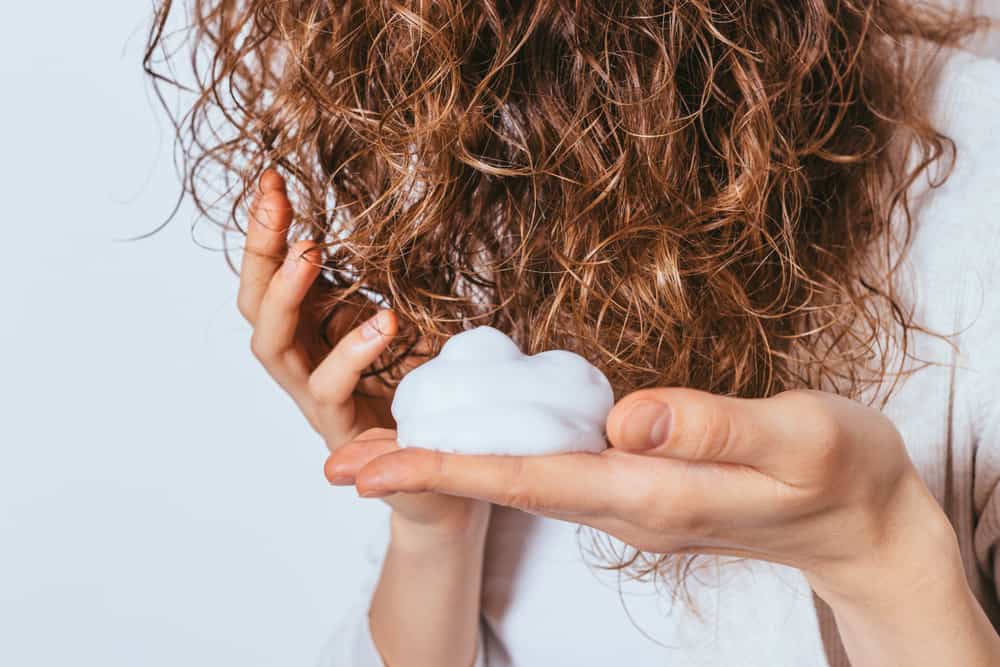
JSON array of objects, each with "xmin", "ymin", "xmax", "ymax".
[{"xmin": 147, "ymin": 0, "xmax": 1000, "ymax": 667}]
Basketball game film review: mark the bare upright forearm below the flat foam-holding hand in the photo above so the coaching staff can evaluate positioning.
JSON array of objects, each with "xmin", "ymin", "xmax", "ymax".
[{"xmin": 369, "ymin": 505, "xmax": 489, "ymax": 667}]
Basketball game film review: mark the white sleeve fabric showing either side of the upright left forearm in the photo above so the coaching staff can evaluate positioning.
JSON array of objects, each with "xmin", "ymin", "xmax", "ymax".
[{"xmin": 317, "ymin": 512, "xmax": 488, "ymax": 667}]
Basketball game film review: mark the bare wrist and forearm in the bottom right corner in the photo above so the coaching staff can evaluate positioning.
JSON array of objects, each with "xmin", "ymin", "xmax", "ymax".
[{"xmin": 817, "ymin": 478, "xmax": 1000, "ymax": 667}]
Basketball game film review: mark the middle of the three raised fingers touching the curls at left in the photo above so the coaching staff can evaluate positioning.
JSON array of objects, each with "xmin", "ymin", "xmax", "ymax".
[{"xmin": 250, "ymin": 241, "xmax": 321, "ymax": 396}]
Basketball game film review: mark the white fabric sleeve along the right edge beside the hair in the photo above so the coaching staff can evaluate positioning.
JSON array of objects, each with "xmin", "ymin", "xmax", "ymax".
[{"xmin": 916, "ymin": 52, "xmax": 1000, "ymax": 627}]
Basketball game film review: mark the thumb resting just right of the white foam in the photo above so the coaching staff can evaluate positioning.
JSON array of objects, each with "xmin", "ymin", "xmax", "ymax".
[{"xmin": 607, "ymin": 388, "xmax": 877, "ymax": 479}]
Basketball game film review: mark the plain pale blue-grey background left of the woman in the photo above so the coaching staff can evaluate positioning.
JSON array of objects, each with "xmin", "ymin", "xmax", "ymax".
[{"xmin": 0, "ymin": 0, "xmax": 1000, "ymax": 667}]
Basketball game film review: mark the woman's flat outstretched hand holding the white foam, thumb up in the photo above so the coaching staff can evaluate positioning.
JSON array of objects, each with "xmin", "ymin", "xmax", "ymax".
[{"xmin": 327, "ymin": 388, "xmax": 961, "ymax": 605}]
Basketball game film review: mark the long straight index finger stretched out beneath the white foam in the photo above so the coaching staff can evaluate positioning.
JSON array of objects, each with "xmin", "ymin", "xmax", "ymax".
[{"xmin": 354, "ymin": 447, "xmax": 783, "ymax": 537}]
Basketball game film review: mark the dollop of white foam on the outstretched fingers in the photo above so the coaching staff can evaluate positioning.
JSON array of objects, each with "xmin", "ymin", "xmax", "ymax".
[{"xmin": 391, "ymin": 326, "xmax": 614, "ymax": 456}]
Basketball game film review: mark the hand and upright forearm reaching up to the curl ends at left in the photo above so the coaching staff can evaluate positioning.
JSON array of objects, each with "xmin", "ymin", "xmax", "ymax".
[{"xmin": 237, "ymin": 171, "xmax": 490, "ymax": 667}]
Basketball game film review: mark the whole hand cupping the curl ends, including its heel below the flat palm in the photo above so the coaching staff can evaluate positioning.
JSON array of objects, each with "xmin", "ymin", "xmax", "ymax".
[{"xmin": 238, "ymin": 170, "xmax": 489, "ymax": 536}]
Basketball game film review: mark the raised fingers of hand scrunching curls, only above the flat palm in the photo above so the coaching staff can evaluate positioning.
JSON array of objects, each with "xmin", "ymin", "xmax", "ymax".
[{"xmin": 237, "ymin": 170, "xmax": 409, "ymax": 451}]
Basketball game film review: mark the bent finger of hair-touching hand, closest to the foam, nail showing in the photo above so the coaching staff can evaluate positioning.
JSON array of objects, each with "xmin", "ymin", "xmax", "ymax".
[{"xmin": 308, "ymin": 310, "xmax": 398, "ymax": 418}]
